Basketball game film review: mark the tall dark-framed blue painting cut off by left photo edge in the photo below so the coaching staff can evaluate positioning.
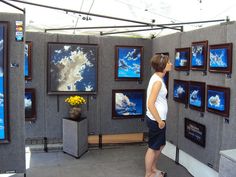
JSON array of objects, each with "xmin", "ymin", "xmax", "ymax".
[{"xmin": 0, "ymin": 21, "xmax": 9, "ymax": 143}]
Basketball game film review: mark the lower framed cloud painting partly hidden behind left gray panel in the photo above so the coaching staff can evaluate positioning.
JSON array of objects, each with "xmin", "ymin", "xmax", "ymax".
[{"xmin": 24, "ymin": 88, "xmax": 36, "ymax": 121}]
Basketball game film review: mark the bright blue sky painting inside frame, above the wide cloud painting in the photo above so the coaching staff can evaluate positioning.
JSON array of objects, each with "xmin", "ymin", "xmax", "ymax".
[{"xmin": 117, "ymin": 47, "xmax": 142, "ymax": 79}]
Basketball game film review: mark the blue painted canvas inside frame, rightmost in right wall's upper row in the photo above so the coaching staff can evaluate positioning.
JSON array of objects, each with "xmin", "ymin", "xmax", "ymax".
[{"xmin": 210, "ymin": 48, "xmax": 228, "ymax": 68}]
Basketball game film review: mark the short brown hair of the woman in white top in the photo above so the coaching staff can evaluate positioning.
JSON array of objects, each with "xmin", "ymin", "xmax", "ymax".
[{"xmin": 151, "ymin": 54, "xmax": 169, "ymax": 72}]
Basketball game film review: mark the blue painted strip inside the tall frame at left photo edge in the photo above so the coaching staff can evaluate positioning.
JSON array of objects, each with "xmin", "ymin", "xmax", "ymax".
[{"xmin": 0, "ymin": 25, "xmax": 6, "ymax": 140}]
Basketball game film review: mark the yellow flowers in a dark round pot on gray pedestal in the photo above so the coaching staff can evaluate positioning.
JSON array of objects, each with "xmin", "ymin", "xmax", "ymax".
[{"xmin": 65, "ymin": 95, "xmax": 86, "ymax": 120}]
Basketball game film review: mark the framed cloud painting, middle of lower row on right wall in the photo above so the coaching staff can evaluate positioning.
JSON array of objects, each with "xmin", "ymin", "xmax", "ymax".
[{"xmin": 188, "ymin": 81, "xmax": 206, "ymax": 112}]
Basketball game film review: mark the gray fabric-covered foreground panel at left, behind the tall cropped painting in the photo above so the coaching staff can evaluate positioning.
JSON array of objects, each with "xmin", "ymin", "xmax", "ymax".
[{"xmin": 0, "ymin": 13, "xmax": 25, "ymax": 173}]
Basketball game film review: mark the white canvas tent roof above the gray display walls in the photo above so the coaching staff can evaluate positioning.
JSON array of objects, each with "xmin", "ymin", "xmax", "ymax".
[{"xmin": 0, "ymin": 0, "xmax": 236, "ymax": 37}]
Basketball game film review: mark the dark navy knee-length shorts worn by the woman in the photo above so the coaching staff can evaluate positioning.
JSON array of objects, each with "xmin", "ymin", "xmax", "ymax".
[{"xmin": 146, "ymin": 116, "xmax": 166, "ymax": 150}]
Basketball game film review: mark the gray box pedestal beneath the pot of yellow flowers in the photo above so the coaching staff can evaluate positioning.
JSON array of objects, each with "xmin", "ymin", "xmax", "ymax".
[{"xmin": 63, "ymin": 117, "xmax": 88, "ymax": 158}]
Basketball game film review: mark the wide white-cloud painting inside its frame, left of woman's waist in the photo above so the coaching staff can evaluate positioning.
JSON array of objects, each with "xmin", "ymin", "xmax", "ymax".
[{"xmin": 115, "ymin": 92, "xmax": 144, "ymax": 117}]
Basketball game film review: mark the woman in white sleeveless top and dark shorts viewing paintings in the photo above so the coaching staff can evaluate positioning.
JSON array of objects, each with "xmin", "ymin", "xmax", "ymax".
[{"xmin": 145, "ymin": 54, "xmax": 172, "ymax": 177}]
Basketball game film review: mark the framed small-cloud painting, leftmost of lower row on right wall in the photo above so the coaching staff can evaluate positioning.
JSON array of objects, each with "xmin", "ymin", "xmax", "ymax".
[{"xmin": 173, "ymin": 79, "xmax": 188, "ymax": 104}]
